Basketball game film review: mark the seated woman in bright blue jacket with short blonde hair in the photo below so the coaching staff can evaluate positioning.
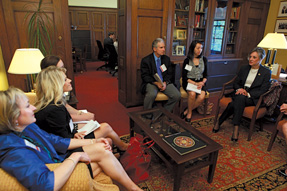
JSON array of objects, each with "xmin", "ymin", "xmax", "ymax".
[{"xmin": 0, "ymin": 87, "xmax": 141, "ymax": 191}]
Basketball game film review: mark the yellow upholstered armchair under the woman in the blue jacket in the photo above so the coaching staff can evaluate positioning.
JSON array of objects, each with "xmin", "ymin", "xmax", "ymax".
[{"xmin": 0, "ymin": 163, "xmax": 93, "ymax": 191}]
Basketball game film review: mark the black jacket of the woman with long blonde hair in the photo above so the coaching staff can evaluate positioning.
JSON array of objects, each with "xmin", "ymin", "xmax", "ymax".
[{"xmin": 35, "ymin": 103, "xmax": 76, "ymax": 138}]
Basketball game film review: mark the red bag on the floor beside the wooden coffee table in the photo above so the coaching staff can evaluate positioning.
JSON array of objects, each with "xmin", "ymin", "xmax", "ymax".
[{"xmin": 120, "ymin": 134, "xmax": 154, "ymax": 184}]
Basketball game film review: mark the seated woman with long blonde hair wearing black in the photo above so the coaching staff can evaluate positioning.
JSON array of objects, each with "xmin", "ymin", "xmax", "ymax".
[{"xmin": 35, "ymin": 66, "xmax": 128, "ymax": 150}]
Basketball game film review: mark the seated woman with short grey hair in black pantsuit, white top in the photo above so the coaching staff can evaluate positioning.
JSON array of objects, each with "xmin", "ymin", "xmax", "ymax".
[{"xmin": 212, "ymin": 47, "xmax": 271, "ymax": 142}]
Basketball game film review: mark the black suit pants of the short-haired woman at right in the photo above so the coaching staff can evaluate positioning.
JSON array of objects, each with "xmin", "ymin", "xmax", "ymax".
[{"xmin": 218, "ymin": 95, "xmax": 255, "ymax": 126}]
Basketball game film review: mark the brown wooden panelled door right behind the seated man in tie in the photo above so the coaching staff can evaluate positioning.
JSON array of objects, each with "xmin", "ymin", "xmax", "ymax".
[{"xmin": 118, "ymin": 0, "xmax": 169, "ymax": 107}]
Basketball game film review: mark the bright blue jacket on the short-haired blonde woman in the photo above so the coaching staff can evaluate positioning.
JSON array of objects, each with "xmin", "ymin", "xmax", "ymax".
[{"xmin": 0, "ymin": 123, "xmax": 70, "ymax": 191}]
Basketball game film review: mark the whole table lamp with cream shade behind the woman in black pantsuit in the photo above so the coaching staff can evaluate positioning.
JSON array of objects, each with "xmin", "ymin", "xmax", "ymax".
[{"xmin": 257, "ymin": 33, "xmax": 287, "ymax": 68}]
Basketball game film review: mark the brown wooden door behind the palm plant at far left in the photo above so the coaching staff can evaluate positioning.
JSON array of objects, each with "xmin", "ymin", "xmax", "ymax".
[{"xmin": 0, "ymin": 0, "xmax": 74, "ymax": 91}]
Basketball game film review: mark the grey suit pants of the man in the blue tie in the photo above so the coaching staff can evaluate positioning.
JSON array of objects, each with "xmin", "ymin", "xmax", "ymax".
[{"xmin": 144, "ymin": 83, "xmax": 181, "ymax": 112}]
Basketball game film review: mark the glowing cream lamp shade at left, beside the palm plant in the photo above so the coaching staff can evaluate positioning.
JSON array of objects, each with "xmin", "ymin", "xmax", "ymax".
[{"xmin": 8, "ymin": 48, "xmax": 44, "ymax": 74}]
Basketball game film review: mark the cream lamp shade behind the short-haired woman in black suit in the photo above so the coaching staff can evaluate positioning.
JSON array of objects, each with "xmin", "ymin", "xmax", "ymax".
[{"xmin": 257, "ymin": 33, "xmax": 287, "ymax": 49}]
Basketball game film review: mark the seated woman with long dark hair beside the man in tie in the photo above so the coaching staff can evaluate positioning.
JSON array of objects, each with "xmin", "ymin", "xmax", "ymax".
[{"xmin": 181, "ymin": 40, "xmax": 207, "ymax": 122}]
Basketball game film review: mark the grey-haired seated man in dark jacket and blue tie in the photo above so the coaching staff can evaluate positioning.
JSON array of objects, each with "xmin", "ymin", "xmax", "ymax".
[{"xmin": 141, "ymin": 38, "xmax": 180, "ymax": 112}]
